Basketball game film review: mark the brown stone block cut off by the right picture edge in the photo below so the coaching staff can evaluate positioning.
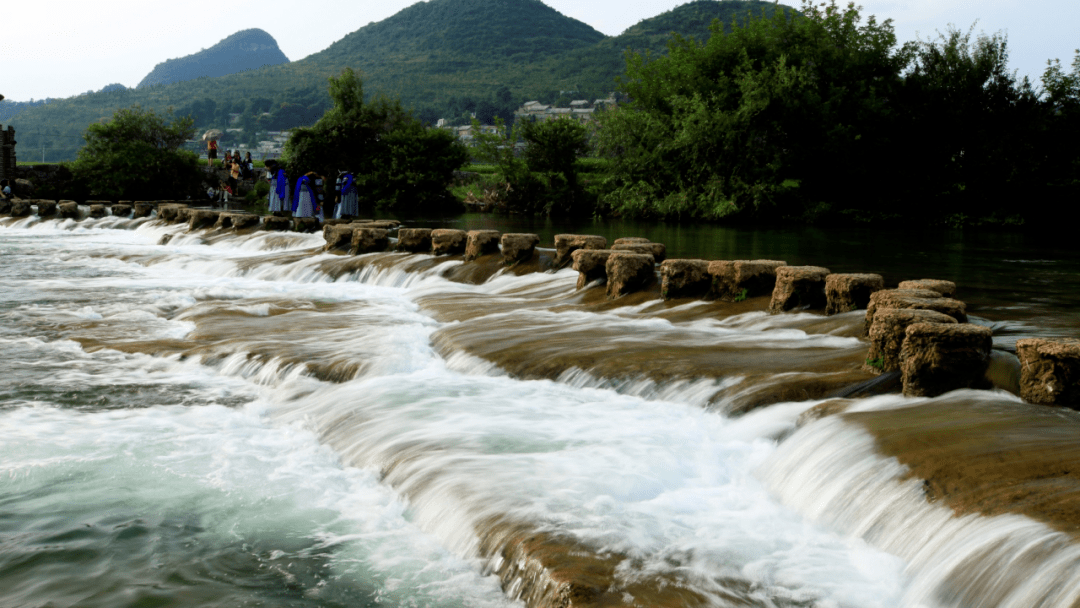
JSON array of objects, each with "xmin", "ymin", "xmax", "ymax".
[{"xmin": 1016, "ymin": 338, "xmax": 1080, "ymax": 409}]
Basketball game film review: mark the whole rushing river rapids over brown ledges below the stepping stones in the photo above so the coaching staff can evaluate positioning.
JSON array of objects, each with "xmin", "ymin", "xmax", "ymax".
[{"xmin": 0, "ymin": 210, "xmax": 1080, "ymax": 608}]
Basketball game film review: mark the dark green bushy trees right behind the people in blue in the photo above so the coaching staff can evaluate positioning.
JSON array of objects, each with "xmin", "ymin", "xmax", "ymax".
[{"xmin": 283, "ymin": 69, "xmax": 469, "ymax": 213}]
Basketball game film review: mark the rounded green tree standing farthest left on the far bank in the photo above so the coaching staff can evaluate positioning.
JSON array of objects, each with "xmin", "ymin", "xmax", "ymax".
[{"xmin": 72, "ymin": 106, "xmax": 203, "ymax": 200}]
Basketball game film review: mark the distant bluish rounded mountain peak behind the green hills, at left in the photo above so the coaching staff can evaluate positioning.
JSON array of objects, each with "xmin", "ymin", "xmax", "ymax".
[{"xmin": 136, "ymin": 29, "xmax": 288, "ymax": 89}]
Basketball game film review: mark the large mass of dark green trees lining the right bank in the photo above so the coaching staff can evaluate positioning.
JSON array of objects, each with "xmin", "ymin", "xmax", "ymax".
[{"xmin": 598, "ymin": 1, "xmax": 1078, "ymax": 224}]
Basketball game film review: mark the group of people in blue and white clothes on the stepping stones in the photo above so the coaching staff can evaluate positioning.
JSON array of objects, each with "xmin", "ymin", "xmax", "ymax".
[{"xmin": 266, "ymin": 160, "xmax": 360, "ymax": 220}]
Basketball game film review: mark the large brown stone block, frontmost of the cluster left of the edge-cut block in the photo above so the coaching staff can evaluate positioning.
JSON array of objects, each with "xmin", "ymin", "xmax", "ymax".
[{"xmin": 900, "ymin": 323, "xmax": 993, "ymax": 397}]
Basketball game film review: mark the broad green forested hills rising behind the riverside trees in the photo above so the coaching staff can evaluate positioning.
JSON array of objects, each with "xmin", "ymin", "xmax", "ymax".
[{"xmin": 10, "ymin": 0, "xmax": 789, "ymax": 160}]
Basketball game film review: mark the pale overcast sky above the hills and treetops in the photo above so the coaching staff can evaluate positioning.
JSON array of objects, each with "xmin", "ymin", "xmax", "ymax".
[{"xmin": 0, "ymin": 0, "xmax": 1080, "ymax": 102}]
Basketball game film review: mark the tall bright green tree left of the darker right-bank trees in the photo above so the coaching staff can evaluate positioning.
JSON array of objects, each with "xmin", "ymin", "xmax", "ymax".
[{"xmin": 598, "ymin": 1, "xmax": 907, "ymax": 219}]
